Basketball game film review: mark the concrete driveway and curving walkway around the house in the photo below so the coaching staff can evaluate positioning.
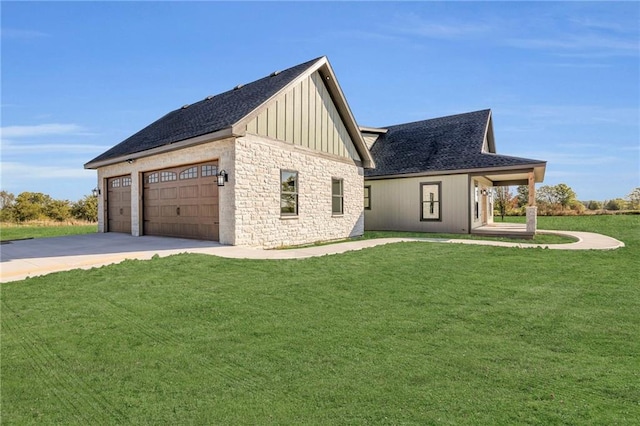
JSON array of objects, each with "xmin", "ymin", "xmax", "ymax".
[{"xmin": 0, "ymin": 231, "xmax": 624, "ymax": 282}]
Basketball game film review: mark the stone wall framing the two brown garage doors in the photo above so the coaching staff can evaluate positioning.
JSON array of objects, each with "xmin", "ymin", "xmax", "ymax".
[{"xmin": 98, "ymin": 139, "xmax": 235, "ymax": 244}]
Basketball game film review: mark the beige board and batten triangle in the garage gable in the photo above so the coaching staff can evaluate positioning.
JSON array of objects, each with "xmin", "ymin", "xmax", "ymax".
[{"xmin": 247, "ymin": 72, "xmax": 361, "ymax": 161}]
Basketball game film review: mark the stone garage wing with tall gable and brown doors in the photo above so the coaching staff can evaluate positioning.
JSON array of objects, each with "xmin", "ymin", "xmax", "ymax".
[{"xmin": 85, "ymin": 57, "xmax": 374, "ymax": 247}]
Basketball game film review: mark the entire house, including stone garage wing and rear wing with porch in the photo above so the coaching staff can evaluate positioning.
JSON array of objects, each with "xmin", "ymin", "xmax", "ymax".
[{"xmin": 85, "ymin": 57, "xmax": 545, "ymax": 248}]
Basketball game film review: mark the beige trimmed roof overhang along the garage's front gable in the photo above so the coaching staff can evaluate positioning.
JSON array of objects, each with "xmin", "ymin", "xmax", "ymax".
[{"xmin": 231, "ymin": 56, "xmax": 375, "ymax": 169}]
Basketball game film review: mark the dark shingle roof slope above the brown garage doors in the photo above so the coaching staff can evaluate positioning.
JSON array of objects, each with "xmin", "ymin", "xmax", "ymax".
[{"xmin": 88, "ymin": 58, "xmax": 321, "ymax": 164}]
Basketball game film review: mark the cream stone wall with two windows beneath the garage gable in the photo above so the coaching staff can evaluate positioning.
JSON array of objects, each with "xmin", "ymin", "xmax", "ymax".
[{"xmin": 235, "ymin": 135, "xmax": 364, "ymax": 247}]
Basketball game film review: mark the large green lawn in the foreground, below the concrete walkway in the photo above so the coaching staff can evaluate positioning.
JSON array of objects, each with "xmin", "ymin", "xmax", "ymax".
[{"xmin": 1, "ymin": 216, "xmax": 640, "ymax": 425}]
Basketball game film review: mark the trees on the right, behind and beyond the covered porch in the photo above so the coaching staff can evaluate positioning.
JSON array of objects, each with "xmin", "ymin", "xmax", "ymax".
[{"xmin": 494, "ymin": 183, "xmax": 640, "ymax": 216}]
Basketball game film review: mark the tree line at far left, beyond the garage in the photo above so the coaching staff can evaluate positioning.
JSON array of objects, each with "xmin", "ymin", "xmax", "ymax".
[{"xmin": 0, "ymin": 191, "xmax": 98, "ymax": 223}]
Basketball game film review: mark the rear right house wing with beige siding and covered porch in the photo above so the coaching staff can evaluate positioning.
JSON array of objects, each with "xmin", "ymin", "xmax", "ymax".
[{"xmin": 361, "ymin": 110, "xmax": 546, "ymax": 236}]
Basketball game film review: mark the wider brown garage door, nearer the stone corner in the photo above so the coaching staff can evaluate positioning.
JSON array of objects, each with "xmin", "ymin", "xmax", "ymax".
[{"xmin": 143, "ymin": 161, "xmax": 220, "ymax": 241}]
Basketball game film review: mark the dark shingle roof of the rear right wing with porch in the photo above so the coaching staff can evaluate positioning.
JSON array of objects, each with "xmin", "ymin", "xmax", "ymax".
[{"xmin": 365, "ymin": 109, "xmax": 544, "ymax": 177}]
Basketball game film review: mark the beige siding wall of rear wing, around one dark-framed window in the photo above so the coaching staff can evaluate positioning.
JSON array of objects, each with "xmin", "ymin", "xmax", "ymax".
[{"xmin": 364, "ymin": 174, "xmax": 469, "ymax": 234}]
